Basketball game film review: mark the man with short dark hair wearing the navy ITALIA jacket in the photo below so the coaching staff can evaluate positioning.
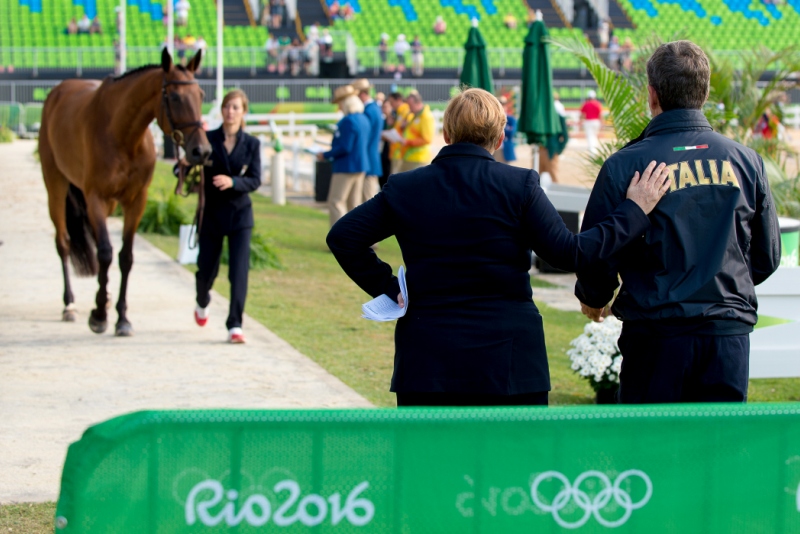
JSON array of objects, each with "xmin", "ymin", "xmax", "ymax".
[{"xmin": 575, "ymin": 41, "xmax": 780, "ymax": 403}]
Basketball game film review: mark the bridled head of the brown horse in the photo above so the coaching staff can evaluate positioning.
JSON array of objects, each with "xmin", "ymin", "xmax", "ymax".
[{"xmin": 156, "ymin": 48, "xmax": 211, "ymax": 165}]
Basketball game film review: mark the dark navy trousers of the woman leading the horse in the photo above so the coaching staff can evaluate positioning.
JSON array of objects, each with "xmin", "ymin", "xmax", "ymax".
[{"xmin": 195, "ymin": 228, "xmax": 253, "ymax": 329}]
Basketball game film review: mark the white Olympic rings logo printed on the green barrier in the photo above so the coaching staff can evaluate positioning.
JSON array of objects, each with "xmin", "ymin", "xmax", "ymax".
[{"xmin": 531, "ymin": 469, "xmax": 653, "ymax": 529}]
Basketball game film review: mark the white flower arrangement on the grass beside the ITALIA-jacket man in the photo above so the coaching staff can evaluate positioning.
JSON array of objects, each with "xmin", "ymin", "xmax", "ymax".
[{"xmin": 567, "ymin": 317, "xmax": 622, "ymax": 391}]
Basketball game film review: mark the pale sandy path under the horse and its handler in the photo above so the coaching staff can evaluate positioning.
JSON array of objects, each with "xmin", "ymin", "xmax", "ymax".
[{"xmin": 0, "ymin": 141, "xmax": 369, "ymax": 503}]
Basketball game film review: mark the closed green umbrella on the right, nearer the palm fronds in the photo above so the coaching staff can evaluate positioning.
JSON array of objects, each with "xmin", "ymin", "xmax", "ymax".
[{"xmin": 517, "ymin": 20, "xmax": 562, "ymax": 145}]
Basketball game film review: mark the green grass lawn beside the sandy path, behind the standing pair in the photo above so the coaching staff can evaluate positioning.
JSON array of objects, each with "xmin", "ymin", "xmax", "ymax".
[{"xmin": 145, "ymin": 163, "xmax": 800, "ymax": 406}]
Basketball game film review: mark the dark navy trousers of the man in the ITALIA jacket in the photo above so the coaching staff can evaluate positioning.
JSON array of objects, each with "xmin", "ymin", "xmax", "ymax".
[{"xmin": 619, "ymin": 329, "xmax": 750, "ymax": 404}]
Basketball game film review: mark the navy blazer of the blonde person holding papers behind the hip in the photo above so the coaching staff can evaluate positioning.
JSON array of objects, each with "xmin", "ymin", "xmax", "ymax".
[{"xmin": 327, "ymin": 143, "xmax": 649, "ymax": 395}]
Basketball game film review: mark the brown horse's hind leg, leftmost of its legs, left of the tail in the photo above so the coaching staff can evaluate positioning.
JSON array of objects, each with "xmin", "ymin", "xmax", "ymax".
[{"xmin": 39, "ymin": 138, "xmax": 75, "ymax": 322}]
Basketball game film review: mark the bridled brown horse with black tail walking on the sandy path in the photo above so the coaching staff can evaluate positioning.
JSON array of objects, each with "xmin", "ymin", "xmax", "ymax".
[{"xmin": 39, "ymin": 50, "xmax": 211, "ymax": 336}]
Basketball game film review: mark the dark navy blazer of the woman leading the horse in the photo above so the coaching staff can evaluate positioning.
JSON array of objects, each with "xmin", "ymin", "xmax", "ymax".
[{"xmin": 201, "ymin": 127, "xmax": 261, "ymax": 234}]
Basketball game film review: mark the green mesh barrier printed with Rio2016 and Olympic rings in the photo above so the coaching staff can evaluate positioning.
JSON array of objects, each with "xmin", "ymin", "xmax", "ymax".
[{"xmin": 56, "ymin": 404, "xmax": 800, "ymax": 534}]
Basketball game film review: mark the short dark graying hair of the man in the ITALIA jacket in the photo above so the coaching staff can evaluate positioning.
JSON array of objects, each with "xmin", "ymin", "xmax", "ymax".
[{"xmin": 647, "ymin": 41, "xmax": 711, "ymax": 111}]
